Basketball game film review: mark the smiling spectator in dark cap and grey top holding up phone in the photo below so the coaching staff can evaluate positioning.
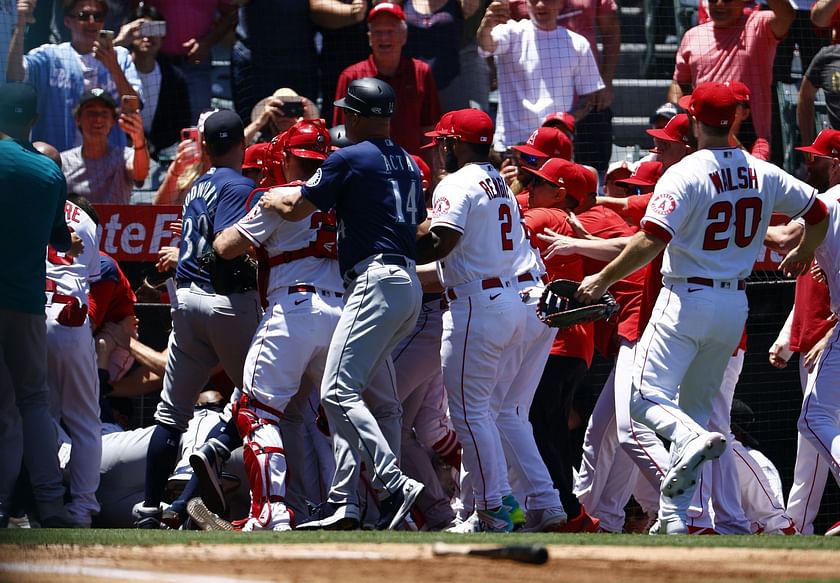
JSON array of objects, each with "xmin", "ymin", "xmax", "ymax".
[{"xmin": 61, "ymin": 88, "xmax": 149, "ymax": 204}]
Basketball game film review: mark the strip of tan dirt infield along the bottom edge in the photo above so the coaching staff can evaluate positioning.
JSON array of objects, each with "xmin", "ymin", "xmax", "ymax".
[{"xmin": 0, "ymin": 544, "xmax": 838, "ymax": 583}]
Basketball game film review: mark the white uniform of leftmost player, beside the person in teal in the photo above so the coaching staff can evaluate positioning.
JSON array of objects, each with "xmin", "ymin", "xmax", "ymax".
[{"xmin": 46, "ymin": 201, "xmax": 102, "ymax": 525}]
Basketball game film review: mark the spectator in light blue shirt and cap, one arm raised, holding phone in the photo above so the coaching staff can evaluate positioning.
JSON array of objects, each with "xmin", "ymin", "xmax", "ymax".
[{"xmin": 6, "ymin": 0, "xmax": 143, "ymax": 151}]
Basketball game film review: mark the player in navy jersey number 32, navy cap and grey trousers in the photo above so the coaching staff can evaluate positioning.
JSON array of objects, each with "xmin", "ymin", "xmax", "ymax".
[{"xmin": 135, "ymin": 110, "xmax": 262, "ymax": 528}]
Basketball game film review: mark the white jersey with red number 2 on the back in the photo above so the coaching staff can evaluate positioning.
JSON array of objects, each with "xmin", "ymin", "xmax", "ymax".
[{"xmin": 431, "ymin": 163, "xmax": 528, "ymax": 287}]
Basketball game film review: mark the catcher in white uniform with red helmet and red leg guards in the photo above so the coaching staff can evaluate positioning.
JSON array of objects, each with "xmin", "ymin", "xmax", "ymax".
[{"xmin": 213, "ymin": 120, "xmax": 343, "ymax": 532}]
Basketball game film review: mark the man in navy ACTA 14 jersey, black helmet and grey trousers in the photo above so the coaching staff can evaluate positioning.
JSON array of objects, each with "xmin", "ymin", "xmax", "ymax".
[{"xmin": 260, "ymin": 77, "xmax": 426, "ymax": 529}]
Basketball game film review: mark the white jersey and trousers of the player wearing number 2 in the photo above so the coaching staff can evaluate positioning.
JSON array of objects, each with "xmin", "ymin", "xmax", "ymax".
[{"xmin": 431, "ymin": 163, "xmax": 528, "ymax": 517}]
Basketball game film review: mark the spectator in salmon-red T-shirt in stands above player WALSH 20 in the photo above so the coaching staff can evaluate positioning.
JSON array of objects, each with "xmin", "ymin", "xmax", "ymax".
[{"xmin": 668, "ymin": 0, "xmax": 795, "ymax": 154}]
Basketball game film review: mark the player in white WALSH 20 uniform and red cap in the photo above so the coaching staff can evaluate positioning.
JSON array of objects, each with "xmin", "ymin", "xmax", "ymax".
[{"xmin": 577, "ymin": 83, "xmax": 828, "ymax": 534}]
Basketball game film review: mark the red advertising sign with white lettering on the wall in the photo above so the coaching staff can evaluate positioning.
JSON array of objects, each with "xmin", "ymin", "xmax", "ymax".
[{"xmin": 95, "ymin": 204, "xmax": 181, "ymax": 261}]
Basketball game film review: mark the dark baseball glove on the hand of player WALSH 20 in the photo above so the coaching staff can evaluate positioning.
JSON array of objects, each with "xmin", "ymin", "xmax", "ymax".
[{"xmin": 537, "ymin": 279, "xmax": 621, "ymax": 328}]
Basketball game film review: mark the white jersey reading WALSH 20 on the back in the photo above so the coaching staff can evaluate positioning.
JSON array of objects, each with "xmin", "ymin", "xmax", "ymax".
[{"xmin": 642, "ymin": 148, "xmax": 816, "ymax": 279}]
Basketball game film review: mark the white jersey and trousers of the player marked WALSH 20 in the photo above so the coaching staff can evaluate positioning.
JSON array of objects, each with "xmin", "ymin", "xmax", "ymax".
[{"xmin": 631, "ymin": 148, "xmax": 822, "ymax": 524}]
